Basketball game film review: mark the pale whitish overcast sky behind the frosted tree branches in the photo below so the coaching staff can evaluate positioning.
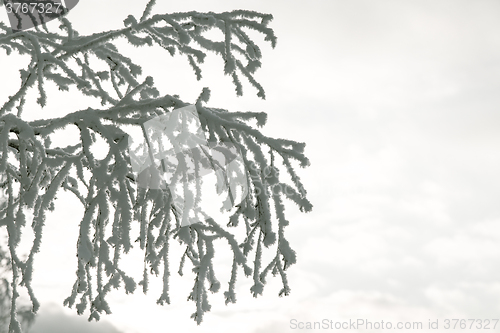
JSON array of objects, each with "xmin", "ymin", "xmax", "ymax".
[{"xmin": 0, "ymin": 0, "xmax": 500, "ymax": 333}]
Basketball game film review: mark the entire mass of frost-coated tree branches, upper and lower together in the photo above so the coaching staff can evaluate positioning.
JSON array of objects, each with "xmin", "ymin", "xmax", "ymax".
[{"xmin": 0, "ymin": 1, "xmax": 312, "ymax": 332}]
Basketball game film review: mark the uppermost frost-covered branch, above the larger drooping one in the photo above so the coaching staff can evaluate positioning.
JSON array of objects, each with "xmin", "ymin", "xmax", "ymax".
[{"xmin": 0, "ymin": 11, "xmax": 276, "ymax": 115}]
